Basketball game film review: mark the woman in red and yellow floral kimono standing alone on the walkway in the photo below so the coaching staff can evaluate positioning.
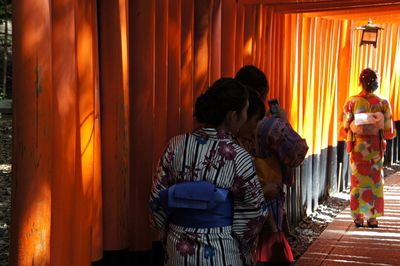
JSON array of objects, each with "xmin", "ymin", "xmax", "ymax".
[{"xmin": 341, "ymin": 68, "xmax": 395, "ymax": 227}]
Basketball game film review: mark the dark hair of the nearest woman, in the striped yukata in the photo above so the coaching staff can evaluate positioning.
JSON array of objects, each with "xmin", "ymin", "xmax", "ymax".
[{"xmin": 194, "ymin": 78, "xmax": 248, "ymax": 126}]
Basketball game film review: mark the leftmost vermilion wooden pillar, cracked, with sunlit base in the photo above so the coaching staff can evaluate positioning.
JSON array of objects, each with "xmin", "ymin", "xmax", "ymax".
[{"xmin": 10, "ymin": 0, "xmax": 53, "ymax": 265}]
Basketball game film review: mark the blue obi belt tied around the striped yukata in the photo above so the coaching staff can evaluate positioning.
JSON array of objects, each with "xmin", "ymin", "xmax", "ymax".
[{"xmin": 160, "ymin": 181, "xmax": 233, "ymax": 228}]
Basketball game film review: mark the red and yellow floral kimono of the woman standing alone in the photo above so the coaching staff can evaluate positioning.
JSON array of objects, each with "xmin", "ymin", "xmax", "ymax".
[{"xmin": 341, "ymin": 91, "xmax": 395, "ymax": 219}]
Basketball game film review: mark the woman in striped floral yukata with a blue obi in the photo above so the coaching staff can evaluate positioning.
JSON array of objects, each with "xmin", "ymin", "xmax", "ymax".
[{"xmin": 150, "ymin": 78, "xmax": 267, "ymax": 266}]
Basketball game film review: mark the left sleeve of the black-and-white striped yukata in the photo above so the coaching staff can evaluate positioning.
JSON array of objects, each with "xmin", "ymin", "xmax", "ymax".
[{"xmin": 149, "ymin": 142, "xmax": 174, "ymax": 235}]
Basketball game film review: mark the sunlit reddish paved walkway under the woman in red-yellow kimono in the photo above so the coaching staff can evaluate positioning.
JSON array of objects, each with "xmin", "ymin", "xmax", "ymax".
[{"xmin": 296, "ymin": 172, "xmax": 400, "ymax": 266}]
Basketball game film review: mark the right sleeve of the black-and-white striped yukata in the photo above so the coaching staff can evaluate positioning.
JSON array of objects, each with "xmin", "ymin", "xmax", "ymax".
[{"xmin": 232, "ymin": 150, "xmax": 268, "ymax": 265}]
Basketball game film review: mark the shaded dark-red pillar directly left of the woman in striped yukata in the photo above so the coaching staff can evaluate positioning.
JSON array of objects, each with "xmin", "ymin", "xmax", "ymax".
[{"xmin": 128, "ymin": 0, "xmax": 158, "ymax": 251}]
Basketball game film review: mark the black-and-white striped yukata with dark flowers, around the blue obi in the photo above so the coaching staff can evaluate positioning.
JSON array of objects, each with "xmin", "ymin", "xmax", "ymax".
[{"xmin": 150, "ymin": 128, "xmax": 267, "ymax": 266}]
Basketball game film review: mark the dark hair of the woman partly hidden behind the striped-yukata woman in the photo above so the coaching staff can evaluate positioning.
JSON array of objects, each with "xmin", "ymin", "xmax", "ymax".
[{"xmin": 235, "ymin": 65, "xmax": 269, "ymax": 97}]
